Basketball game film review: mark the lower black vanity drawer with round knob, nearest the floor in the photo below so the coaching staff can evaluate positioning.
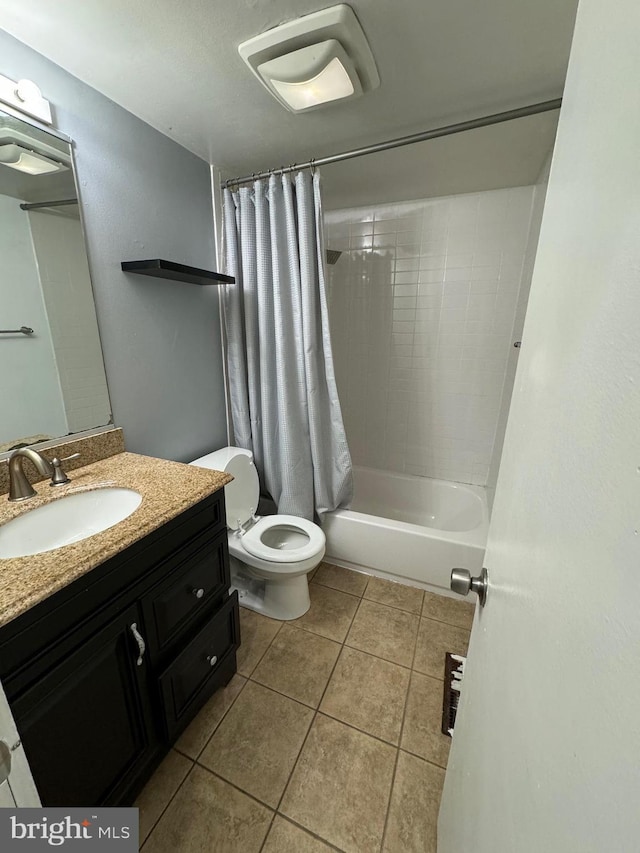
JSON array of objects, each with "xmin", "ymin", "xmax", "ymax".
[{"xmin": 159, "ymin": 592, "xmax": 240, "ymax": 738}]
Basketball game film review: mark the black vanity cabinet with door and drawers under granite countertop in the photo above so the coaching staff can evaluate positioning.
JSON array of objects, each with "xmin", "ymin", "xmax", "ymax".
[{"xmin": 0, "ymin": 491, "xmax": 240, "ymax": 806}]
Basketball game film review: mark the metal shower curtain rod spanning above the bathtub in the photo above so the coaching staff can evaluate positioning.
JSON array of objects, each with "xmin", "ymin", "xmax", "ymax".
[{"xmin": 222, "ymin": 98, "xmax": 562, "ymax": 189}]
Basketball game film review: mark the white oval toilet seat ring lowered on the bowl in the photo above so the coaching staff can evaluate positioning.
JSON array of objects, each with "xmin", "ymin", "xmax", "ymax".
[{"xmin": 242, "ymin": 515, "xmax": 326, "ymax": 563}]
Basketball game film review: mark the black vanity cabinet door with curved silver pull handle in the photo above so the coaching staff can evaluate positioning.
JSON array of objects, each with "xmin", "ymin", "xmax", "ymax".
[{"xmin": 12, "ymin": 605, "xmax": 157, "ymax": 806}]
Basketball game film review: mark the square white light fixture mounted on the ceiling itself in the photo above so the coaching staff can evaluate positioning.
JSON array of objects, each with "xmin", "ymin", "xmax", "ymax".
[{"xmin": 238, "ymin": 4, "xmax": 380, "ymax": 113}]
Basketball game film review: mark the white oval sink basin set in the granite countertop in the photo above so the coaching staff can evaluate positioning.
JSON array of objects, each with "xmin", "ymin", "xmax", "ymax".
[{"xmin": 0, "ymin": 487, "xmax": 142, "ymax": 560}]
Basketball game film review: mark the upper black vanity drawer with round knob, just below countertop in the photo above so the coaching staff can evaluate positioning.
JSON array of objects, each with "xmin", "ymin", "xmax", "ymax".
[{"xmin": 142, "ymin": 529, "xmax": 230, "ymax": 655}]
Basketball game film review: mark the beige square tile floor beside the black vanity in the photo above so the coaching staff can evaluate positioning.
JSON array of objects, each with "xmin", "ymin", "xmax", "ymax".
[{"xmin": 136, "ymin": 563, "xmax": 473, "ymax": 853}]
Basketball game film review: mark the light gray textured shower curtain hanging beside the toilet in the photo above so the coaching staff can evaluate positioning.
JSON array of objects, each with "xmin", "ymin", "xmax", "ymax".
[{"xmin": 223, "ymin": 171, "xmax": 352, "ymax": 520}]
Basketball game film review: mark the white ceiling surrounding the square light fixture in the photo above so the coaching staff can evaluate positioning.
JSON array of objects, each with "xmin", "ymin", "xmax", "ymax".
[{"xmin": 0, "ymin": 0, "xmax": 577, "ymax": 202}]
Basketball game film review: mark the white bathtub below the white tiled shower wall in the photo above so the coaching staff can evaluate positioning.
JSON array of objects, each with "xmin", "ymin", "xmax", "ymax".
[{"xmin": 322, "ymin": 467, "xmax": 489, "ymax": 592}]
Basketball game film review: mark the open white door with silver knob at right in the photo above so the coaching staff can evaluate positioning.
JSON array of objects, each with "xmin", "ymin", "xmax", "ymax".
[{"xmin": 438, "ymin": 0, "xmax": 640, "ymax": 853}]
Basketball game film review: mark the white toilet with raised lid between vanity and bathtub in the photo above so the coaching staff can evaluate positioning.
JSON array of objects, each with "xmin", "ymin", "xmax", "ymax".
[{"xmin": 191, "ymin": 447, "xmax": 326, "ymax": 619}]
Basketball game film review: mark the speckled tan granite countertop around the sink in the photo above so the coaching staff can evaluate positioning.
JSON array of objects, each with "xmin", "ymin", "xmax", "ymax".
[{"xmin": 0, "ymin": 453, "xmax": 233, "ymax": 625}]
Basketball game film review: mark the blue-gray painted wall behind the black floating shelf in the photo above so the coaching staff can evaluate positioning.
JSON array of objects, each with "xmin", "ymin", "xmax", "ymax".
[{"xmin": 0, "ymin": 31, "xmax": 226, "ymax": 461}]
